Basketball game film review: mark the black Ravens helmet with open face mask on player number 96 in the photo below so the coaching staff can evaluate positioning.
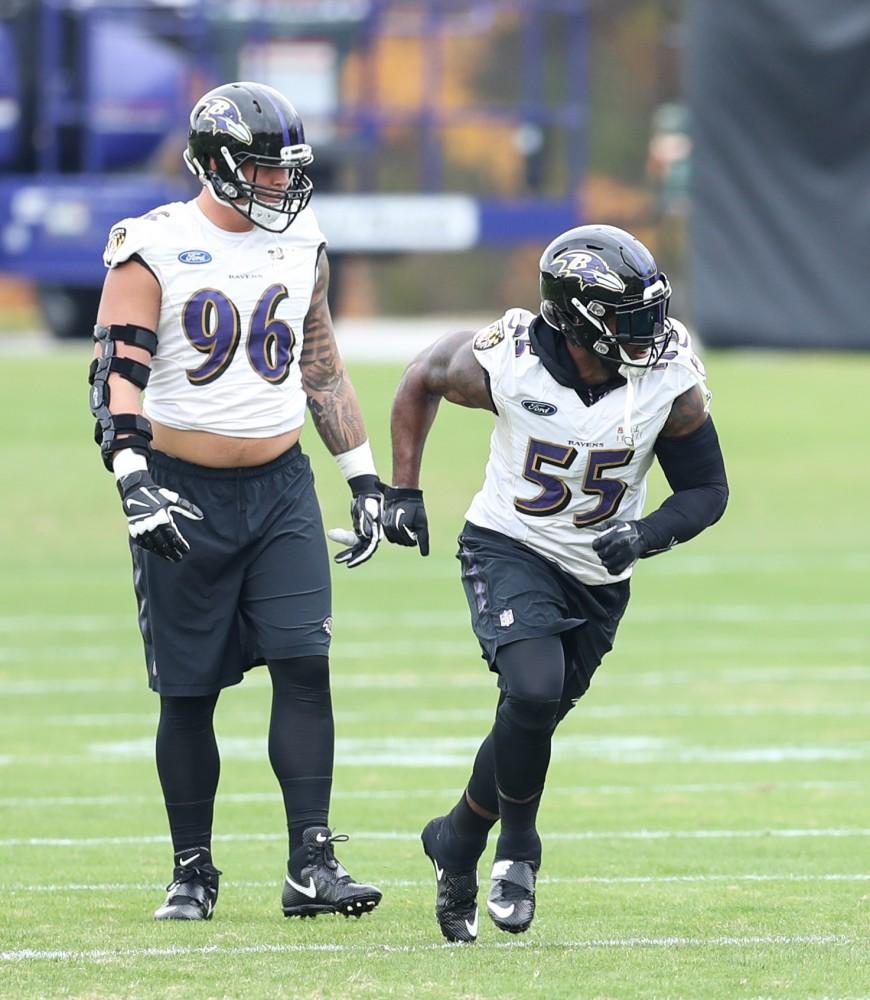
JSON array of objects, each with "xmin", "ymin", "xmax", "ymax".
[{"xmin": 184, "ymin": 83, "xmax": 314, "ymax": 233}]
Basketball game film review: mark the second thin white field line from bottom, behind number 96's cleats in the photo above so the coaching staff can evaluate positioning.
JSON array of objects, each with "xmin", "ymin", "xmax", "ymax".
[{"xmin": 6, "ymin": 873, "xmax": 870, "ymax": 894}]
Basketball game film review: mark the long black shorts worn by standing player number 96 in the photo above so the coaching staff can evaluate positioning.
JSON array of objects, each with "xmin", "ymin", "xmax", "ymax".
[{"xmin": 130, "ymin": 444, "xmax": 332, "ymax": 695}]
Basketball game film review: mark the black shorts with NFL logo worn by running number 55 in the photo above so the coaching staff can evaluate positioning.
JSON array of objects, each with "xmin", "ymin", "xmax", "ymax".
[{"xmin": 457, "ymin": 522, "xmax": 630, "ymax": 698}]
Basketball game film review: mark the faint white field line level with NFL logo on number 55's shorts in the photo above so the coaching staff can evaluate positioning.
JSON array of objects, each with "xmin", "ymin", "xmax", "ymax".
[{"xmin": 0, "ymin": 602, "xmax": 870, "ymax": 633}]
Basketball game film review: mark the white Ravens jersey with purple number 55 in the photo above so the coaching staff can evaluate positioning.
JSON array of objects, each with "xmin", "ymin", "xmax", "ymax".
[{"xmin": 466, "ymin": 309, "xmax": 710, "ymax": 585}]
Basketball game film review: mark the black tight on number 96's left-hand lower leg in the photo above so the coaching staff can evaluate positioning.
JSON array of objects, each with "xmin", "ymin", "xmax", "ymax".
[{"xmin": 156, "ymin": 694, "xmax": 221, "ymax": 854}]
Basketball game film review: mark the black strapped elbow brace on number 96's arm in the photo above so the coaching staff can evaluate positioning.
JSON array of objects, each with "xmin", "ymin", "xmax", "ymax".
[{"xmin": 88, "ymin": 324, "xmax": 157, "ymax": 472}]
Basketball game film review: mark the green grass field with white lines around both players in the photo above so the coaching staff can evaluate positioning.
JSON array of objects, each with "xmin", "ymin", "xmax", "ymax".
[{"xmin": 0, "ymin": 348, "xmax": 870, "ymax": 1000}]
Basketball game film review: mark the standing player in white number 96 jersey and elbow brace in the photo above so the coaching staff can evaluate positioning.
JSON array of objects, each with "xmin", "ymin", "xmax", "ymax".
[{"xmin": 90, "ymin": 83, "xmax": 382, "ymax": 920}]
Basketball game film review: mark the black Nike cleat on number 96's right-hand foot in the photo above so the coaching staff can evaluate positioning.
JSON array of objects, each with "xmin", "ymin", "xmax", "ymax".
[{"xmin": 281, "ymin": 826, "xmax": 381, "ymax": 917}]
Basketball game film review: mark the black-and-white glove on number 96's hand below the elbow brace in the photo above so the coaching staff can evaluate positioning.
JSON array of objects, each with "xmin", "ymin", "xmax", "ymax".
[{"xmin": 118, "ymin": 470, "xmax": 203, "ymax": 562}]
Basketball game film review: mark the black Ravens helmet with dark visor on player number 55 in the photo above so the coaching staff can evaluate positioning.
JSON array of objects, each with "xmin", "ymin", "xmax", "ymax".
[{"xmin": 541, "ymin": 226, "xmax": 671, "ymax": 369}]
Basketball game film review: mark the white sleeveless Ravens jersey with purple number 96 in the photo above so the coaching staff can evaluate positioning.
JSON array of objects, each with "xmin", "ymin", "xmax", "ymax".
[{"xmin": 104, "ymin": 201, "xmax": 326, "ymax": 438}]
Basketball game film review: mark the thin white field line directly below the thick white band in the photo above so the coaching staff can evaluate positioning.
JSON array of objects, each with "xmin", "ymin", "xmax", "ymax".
[{"xmin": 0, "ymin": 781, "xmax": 865, "ymax": 807}]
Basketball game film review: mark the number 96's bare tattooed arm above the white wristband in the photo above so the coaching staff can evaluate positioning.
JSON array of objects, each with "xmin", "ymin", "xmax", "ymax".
[{"xmin": 299, "ymin": 252, "xmax": 366, "ymax": 455}]
